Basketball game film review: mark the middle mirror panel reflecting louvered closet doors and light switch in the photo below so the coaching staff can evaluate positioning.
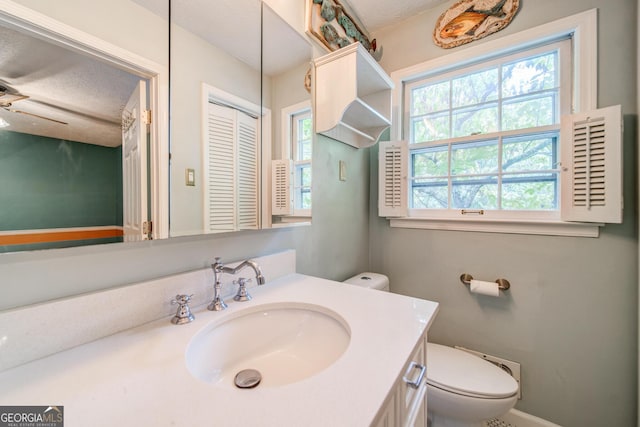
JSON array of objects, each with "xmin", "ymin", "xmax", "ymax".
[{"xmin": 170, "ymin": 0, "xmax": 262, "ymax": 236}]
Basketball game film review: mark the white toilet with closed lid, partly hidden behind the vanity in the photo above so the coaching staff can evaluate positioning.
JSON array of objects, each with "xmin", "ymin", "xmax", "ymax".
[{"xmin": 345, "ymin": 272, "xmax": 518, "ymax": 427}]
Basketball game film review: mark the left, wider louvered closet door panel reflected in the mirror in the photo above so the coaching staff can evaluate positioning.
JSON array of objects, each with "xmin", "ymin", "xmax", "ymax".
[{"xmin": 205, "ymin": 103, "xmax": 237, "ymax": 233}]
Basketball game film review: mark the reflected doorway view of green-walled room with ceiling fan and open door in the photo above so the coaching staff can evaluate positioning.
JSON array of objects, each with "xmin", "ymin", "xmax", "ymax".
[{"xmin": 0, "ymin": 6, "xmax": 165, "ymax": 252}]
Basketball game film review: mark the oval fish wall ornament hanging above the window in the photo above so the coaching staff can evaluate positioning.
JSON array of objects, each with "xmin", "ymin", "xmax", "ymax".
[{"xmin": 433, "ymin": 0, "xmax": 520, "ymax": 49}]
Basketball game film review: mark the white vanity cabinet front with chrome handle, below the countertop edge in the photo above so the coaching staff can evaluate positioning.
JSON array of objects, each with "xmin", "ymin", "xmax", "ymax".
[{"xmin": 373, "ymin": 336, "xmax": 427, "ymax": 427}]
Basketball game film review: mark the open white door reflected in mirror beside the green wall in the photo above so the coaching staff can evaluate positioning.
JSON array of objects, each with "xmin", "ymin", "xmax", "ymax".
[{"xmin": 122, "ymin": 80, "xmax": 151, "ymax": 242}]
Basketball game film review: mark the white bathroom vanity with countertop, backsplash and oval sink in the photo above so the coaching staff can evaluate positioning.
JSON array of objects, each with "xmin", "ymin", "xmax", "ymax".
[{"xmin": 0, "ymin": 262, "xmax": 438, "ymax": 427}]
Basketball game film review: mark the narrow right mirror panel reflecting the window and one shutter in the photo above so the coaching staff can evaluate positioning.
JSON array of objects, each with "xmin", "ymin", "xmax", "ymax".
[{"xmin": 263, "ymin": 4, "xmax": 313, "ymax": 227}]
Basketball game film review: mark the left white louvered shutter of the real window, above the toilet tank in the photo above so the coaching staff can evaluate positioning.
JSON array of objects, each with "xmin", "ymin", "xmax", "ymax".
[{"xmin": 378, "ymin": 141, "xmax": 409, "ymax": 217}]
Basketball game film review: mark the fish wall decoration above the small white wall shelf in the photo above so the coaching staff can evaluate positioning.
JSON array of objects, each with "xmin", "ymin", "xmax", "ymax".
[{"xmin": 306, "ymin": 0, "xmax": 382, "ymax": 61}]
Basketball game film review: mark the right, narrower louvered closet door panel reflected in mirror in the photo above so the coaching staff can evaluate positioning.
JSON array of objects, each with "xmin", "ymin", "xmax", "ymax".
[{"xmin": 236, "ymin": 111, "xmax": 260, "ymax": 230}]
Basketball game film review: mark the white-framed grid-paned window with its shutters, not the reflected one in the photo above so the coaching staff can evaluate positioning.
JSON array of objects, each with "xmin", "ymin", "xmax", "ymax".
[{"xmin": 379, "ymin": 10, "xmax": 622, "ymax": 237}]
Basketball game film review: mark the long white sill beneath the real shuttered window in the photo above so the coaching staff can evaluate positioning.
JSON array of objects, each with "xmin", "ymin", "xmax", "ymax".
[{"xmin": 388, "ymin": 217, "xmax": 604, "ymax": 237}]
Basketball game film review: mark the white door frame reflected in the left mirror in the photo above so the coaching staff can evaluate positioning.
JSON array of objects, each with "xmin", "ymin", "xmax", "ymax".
[{"xmin": 0, "ymin": 0, "xmax": 169, "ymax": 239}]
